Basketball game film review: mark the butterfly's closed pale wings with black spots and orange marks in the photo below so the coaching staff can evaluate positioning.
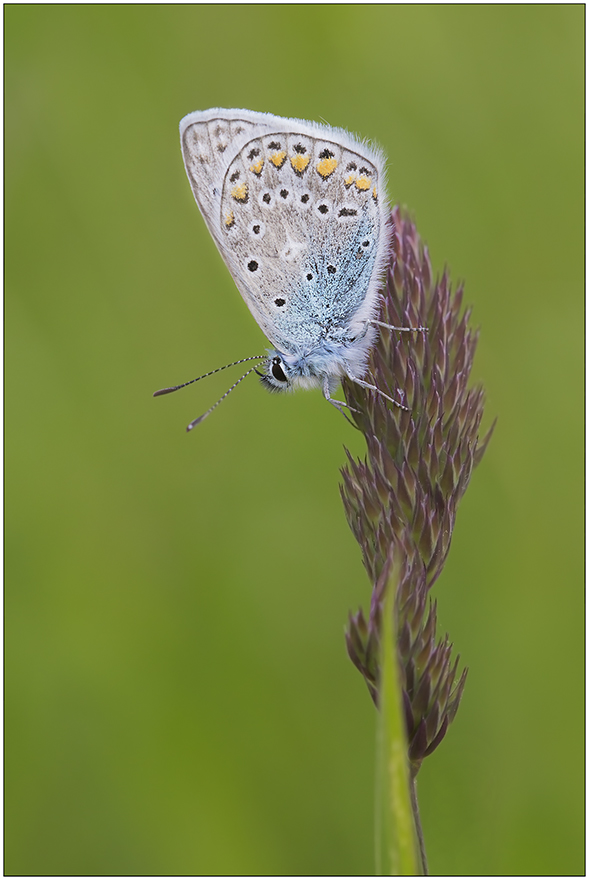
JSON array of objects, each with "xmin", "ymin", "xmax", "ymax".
[{"xmin": 180, "ymin": 109, "xmax": 387, "ymax": 352}]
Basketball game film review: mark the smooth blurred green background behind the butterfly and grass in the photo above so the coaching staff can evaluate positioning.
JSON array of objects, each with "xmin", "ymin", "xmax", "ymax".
[{"xmin": 5, "ymin": 5, "xmax": 584, "ymax": 874}]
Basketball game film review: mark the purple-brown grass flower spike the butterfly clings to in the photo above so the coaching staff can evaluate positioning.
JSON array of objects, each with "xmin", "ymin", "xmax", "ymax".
[{"xmin": 341, "ymin": 208, "xmax": 494, "ymax": 778}]
